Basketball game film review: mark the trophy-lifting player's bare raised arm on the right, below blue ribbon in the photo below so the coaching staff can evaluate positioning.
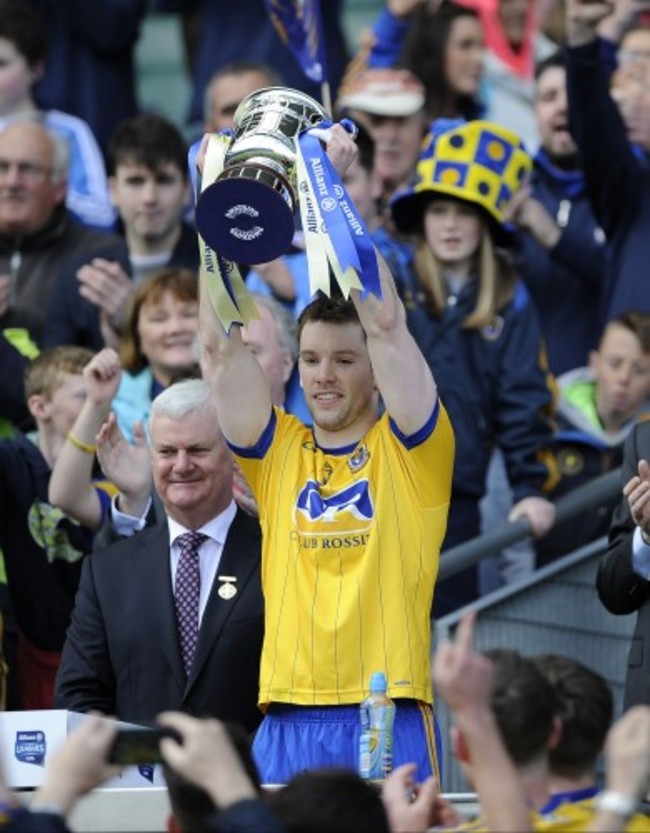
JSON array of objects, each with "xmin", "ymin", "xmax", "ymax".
[{"xmin": 352, "ymin": 252, "xmax": 437, "ymax": 436}]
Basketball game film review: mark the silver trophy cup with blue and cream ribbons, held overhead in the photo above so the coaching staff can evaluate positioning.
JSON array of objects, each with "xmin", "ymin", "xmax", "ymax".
[{"xmin": 191, "ymin": 87, "xmax": 381, "ymax": 332}]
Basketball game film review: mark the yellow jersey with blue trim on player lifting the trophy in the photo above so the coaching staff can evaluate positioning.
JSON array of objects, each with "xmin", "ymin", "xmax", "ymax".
[{"xmin": 231, "ymin": 403, "xmax": 454, "ymax": 706}]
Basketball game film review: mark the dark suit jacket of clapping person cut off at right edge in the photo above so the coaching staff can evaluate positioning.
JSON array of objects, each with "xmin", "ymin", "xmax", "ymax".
[{"xmin": 597, "ymin": 422, "xmax": 650, "ymax": 708}]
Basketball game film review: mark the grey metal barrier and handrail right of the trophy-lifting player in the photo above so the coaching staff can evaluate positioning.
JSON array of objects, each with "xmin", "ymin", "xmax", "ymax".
[{"xmin": 432, "ymin": 468, "xmax": 632, "ymax": 792}]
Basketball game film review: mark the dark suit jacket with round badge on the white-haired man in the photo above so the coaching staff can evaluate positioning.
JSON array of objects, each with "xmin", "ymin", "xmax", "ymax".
[{"xmin": 55, "ymin": 510, "xmax": 264, "ymax": 731}]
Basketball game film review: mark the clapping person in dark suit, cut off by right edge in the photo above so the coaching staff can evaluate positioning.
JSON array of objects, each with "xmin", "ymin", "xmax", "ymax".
[{"xmin": 597, "ymin": 422, "xmax": 650, "ymax": 709}]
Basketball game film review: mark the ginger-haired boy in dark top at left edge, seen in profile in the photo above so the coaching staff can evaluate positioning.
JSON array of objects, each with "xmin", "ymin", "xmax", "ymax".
[{"xmin": 0, "ymin": 347, "xmax": 112, "ymax": 709}]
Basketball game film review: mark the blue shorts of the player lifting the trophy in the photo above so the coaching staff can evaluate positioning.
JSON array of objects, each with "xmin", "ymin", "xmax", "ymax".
[{"xmin": 253, "ymin": 700, "xmax": 440, "ymax": 784}]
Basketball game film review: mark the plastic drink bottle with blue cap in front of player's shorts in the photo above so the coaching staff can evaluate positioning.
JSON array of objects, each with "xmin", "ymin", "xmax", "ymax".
[{"xmin": 359, "ymin": 671, "xmax": 395, "ymax": 781}]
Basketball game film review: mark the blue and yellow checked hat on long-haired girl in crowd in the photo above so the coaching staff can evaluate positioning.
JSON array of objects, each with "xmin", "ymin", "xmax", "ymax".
[{"xmin": 391, "ymin": 119, "xmax": 532, "ymax": 243}]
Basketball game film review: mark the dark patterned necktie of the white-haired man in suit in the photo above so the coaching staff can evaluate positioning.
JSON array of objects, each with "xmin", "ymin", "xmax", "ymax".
[{"xmin": 174, "ymin": 532, "xmax": 208, "ymax": 677}]
